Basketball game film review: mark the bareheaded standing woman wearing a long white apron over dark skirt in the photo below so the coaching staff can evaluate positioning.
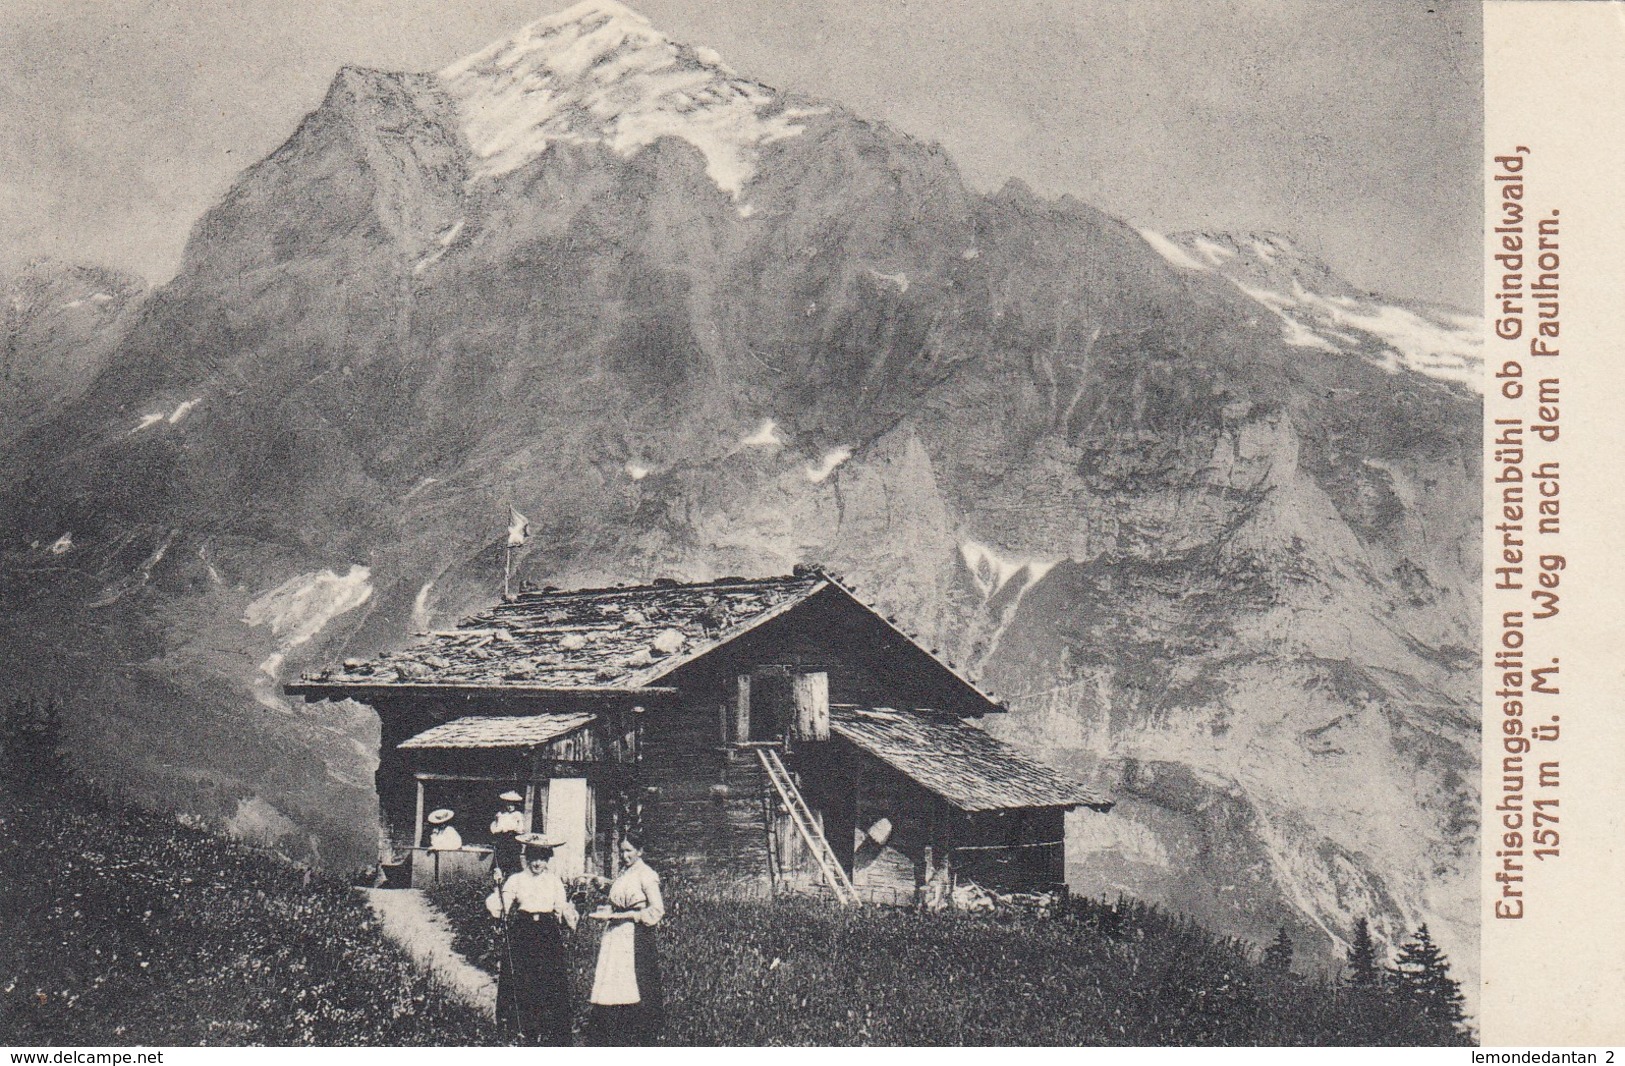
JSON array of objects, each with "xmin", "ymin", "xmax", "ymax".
[{"xmin": 590, "ymin": 834, "xmax": 666, "ymax": 1045}]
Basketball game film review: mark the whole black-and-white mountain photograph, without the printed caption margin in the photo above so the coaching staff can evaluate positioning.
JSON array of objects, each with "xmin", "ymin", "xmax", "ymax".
[{"xmin": 0, "ymin": 0, "xmax": 1514, "ymax": 1055}]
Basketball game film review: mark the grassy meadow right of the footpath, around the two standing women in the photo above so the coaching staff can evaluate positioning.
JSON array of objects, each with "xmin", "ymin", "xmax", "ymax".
[{"xmin": 432, "ymin": 884, "xmax": 1433, "ymax": 1047}]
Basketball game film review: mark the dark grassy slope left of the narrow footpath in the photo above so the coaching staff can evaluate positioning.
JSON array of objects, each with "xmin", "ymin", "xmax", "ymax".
[{"xmin": 0, "ymin": 790, "xmax": 491, "ymax": 1047}]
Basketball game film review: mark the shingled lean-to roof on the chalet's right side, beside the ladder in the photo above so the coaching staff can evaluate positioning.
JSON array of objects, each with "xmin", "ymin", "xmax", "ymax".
[{"xmin": 830, "ymin": 705, "xmax": 1112, "ymax": 811}]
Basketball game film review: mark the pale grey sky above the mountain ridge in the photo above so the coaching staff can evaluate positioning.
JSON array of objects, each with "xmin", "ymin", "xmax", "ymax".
[{"xmin": 0, "ymin": 0, "xmax": 1482, "ymax": 307}]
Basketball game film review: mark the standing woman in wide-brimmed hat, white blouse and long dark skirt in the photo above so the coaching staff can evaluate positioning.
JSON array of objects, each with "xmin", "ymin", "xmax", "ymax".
[{"xmin": 486, "ymin": 834, "xmax": 577, "ymax": 1047}]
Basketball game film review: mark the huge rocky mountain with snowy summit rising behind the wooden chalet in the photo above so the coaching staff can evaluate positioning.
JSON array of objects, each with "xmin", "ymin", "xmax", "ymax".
[{"xmin": 0, "ymin": 2, "xmax": 1479, "ymax": 977}]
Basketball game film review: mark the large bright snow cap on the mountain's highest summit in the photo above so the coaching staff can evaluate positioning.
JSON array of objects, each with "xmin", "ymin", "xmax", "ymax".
[{"xmin": 439, "ymin": 0, "xmax": 821, "ymax": 198}]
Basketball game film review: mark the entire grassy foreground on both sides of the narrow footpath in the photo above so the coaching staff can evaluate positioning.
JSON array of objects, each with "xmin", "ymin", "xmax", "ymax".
[{"xmin": 0, "ymin": 790, "xmax": 1458, "ymax": 1047}]
